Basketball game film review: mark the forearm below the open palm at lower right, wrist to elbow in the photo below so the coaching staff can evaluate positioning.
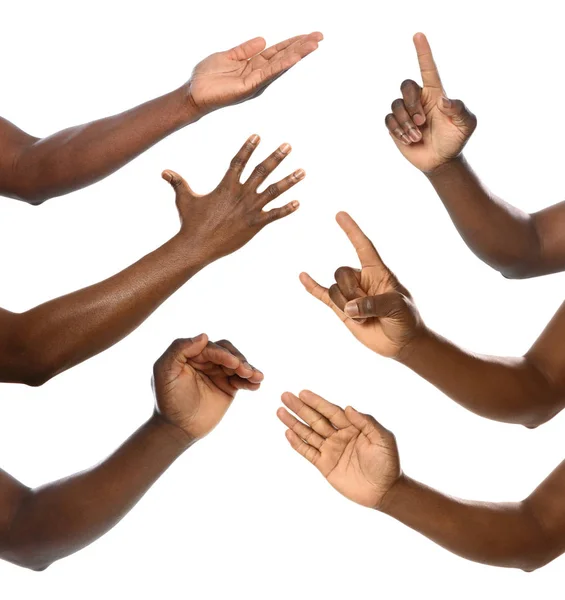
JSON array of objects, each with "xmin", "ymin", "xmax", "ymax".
[{"xmin": 380, "ymin": 476, "xmax": 556, "ymax": 571}]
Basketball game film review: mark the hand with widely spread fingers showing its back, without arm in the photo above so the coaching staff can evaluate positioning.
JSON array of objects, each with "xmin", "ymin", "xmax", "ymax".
[{"xmin": 163, "ymin": 135, "xmax": 306, "ymax": 262}]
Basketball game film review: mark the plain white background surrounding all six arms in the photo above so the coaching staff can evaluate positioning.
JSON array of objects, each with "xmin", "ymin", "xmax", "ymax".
[{"xmin": 0, "ymin": 0, "xmax": 565, "ymax": 600}]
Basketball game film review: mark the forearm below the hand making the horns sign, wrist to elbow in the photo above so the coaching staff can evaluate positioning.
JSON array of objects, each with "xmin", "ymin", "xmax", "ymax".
[{"xmin": 399, "ymin": 330, "xmax": 565, "ymax": 427}]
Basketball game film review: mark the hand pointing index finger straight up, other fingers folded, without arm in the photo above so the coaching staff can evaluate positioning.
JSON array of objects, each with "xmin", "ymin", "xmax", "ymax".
[{"xmin": 385, "ymin": 33, "xmax": 477, "ymax": 173}]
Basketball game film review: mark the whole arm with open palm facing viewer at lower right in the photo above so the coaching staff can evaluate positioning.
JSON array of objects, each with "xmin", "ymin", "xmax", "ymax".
[{"xmin": 277, "ymin": 391, "xmax": 565, "ymax": 571}]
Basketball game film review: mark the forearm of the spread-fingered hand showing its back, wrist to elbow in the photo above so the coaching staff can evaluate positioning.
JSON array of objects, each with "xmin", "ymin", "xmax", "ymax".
[{"xmin": 4, "ymin": 234, "xmax": 207, "ymax": 385}]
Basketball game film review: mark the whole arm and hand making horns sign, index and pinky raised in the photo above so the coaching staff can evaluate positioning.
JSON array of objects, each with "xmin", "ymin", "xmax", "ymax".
[{"xmin": 301, "ymin": 213, "xmax": 565, "ymax": 427}]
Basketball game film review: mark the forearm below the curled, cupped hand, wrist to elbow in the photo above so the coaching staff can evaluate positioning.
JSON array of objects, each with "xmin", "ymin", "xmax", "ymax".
[{"xmin": 2, "ymin": 416, "xmax": 189, "ymax": 570}]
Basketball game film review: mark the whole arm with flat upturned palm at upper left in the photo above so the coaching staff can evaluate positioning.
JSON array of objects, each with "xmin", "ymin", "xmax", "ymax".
[{"xmin": 0, "ymin": 32, "xmax": 323, "ymax": 204}]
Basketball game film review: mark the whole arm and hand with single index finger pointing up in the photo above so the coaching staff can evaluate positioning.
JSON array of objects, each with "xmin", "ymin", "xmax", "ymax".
[{"xmin": 385, "ymin": 33, "xmax": 565, "ymax": 278}]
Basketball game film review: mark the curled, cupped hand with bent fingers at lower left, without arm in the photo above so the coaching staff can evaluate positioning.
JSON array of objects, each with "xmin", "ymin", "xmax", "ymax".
[{"xmin": 153, "ymin": 334, "xmax": 263, "ymax": 443}]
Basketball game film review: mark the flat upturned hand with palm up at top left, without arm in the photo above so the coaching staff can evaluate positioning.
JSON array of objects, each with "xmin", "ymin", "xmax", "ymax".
[{"xmin": 186, "ymin": 32, "xmax": 324, "ymax": 114}]
